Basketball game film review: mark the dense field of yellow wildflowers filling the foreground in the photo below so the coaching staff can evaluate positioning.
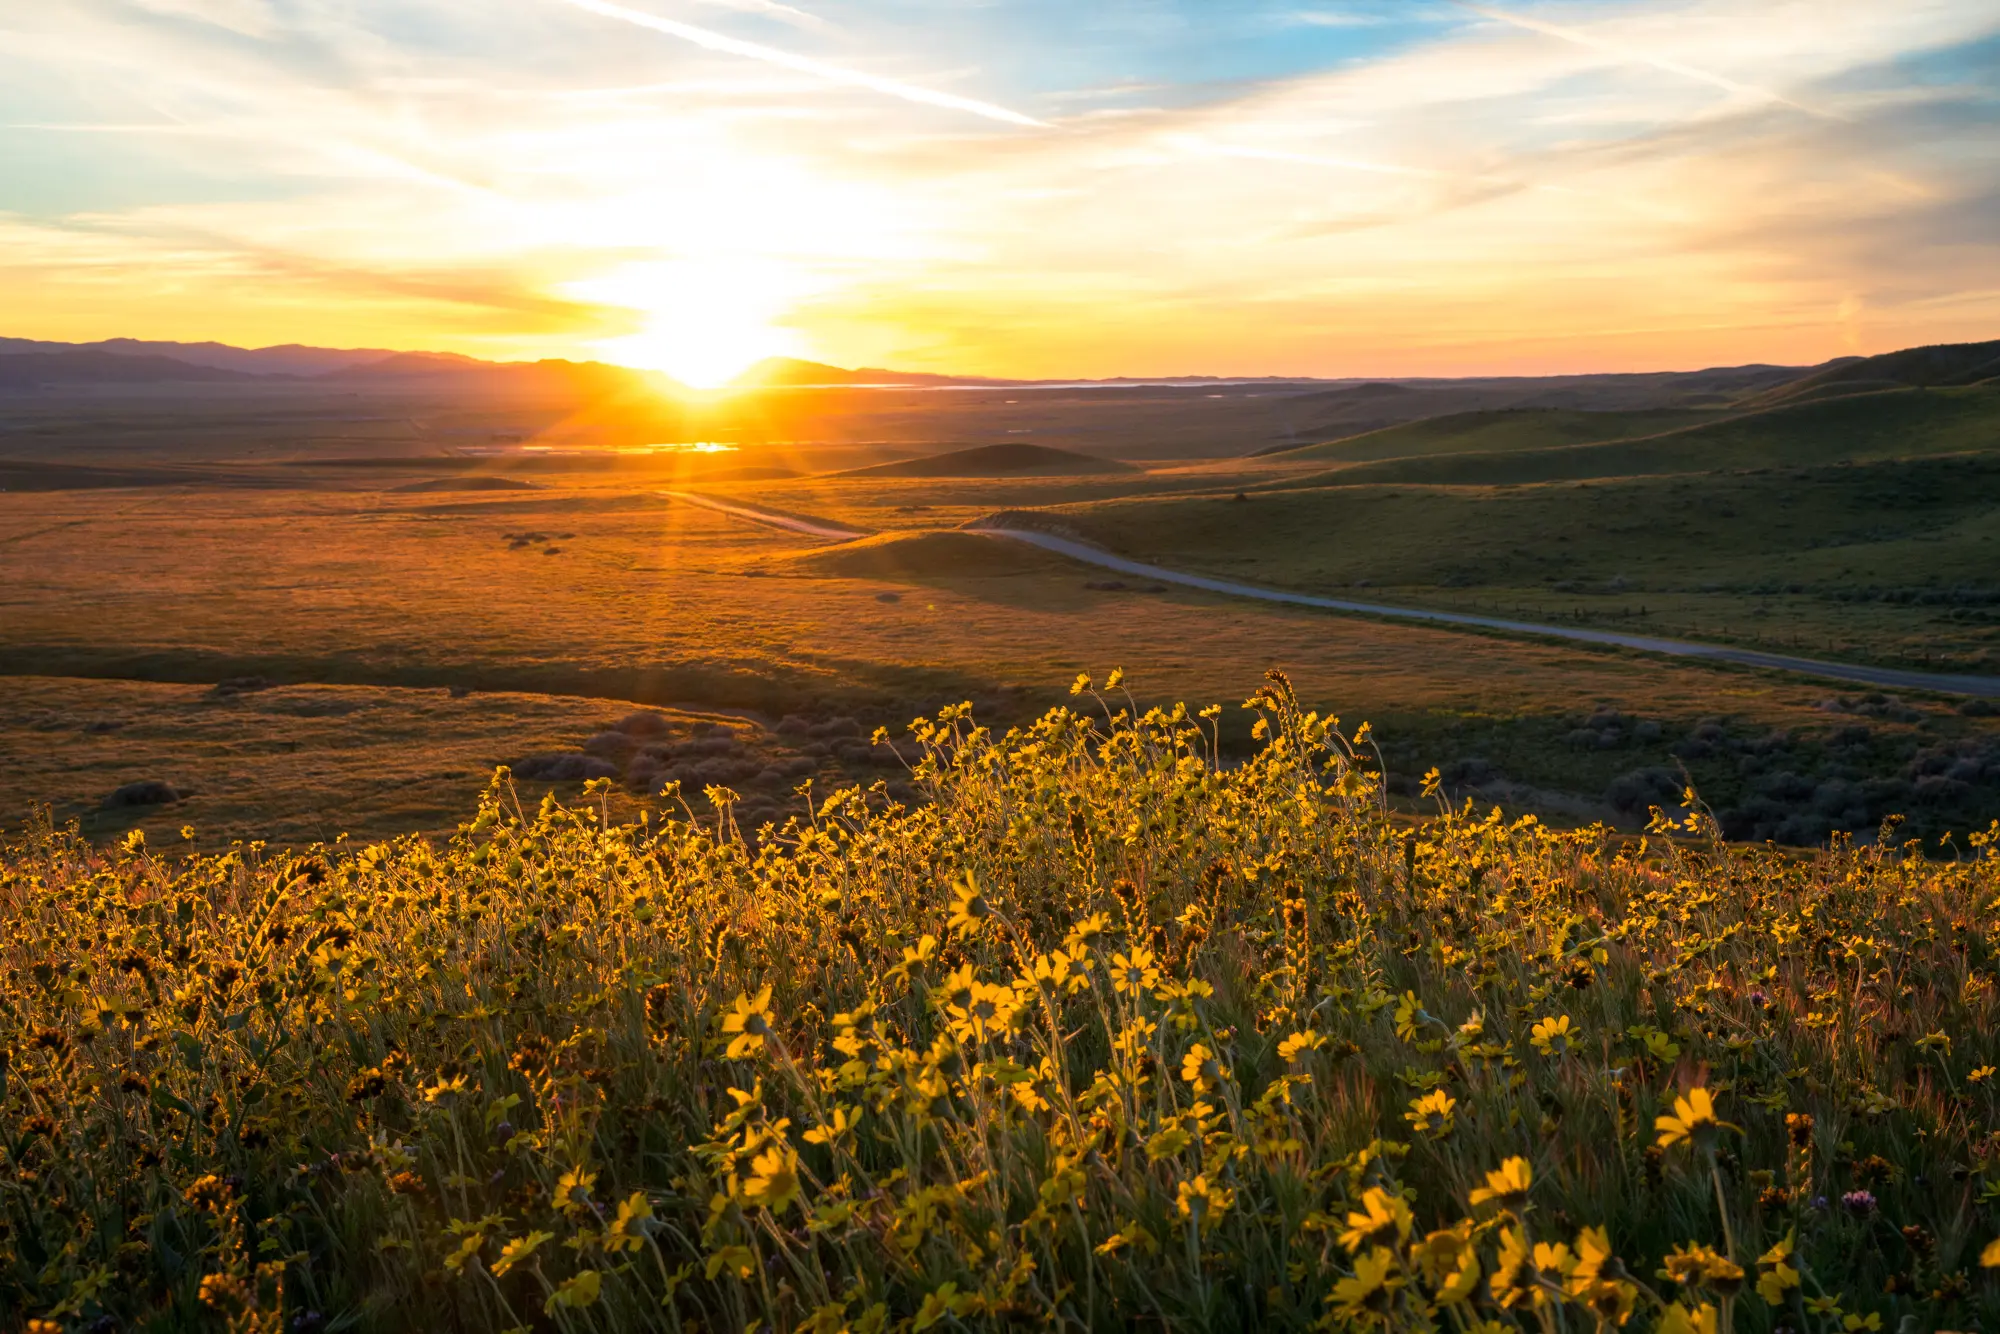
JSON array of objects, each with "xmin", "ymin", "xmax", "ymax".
[{"xmin": 0, "ymin": 678, "xmax": 2000, "ymax": 1334}]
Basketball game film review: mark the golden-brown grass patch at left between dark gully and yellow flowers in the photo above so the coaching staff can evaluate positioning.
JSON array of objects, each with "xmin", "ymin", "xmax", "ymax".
[{"xmin": 0, "ymin": 676, "xmax": 906, "ymax": 850}]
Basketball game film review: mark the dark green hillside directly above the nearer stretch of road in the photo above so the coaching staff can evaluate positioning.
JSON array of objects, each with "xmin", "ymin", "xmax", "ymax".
[{"xmin": 1050, "ymin": 446, "xmax": 2000, "ymax": 670}]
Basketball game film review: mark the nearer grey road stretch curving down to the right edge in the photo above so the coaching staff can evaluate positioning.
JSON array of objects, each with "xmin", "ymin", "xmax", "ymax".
[{"xmin": 966, "ymin": 526, "xmax": 2000, "ymax": 698}]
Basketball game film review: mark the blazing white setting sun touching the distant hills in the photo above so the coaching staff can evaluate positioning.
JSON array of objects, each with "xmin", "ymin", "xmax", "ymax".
[{"xmin": 570, "ymin": 258, "xmax": 800, "ymax": 388}]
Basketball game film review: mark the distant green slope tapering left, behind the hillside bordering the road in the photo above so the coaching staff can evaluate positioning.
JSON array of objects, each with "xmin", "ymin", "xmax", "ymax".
[{"xmin": 1338, "ymin": 386, "xmax": 2000, "ymax": 486}]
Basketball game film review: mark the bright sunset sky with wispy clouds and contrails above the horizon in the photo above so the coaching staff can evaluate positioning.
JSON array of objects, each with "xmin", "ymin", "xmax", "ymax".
[{"xmin": 0, "ymin": 0, "xmax": 2000, "ymax": 384}]
